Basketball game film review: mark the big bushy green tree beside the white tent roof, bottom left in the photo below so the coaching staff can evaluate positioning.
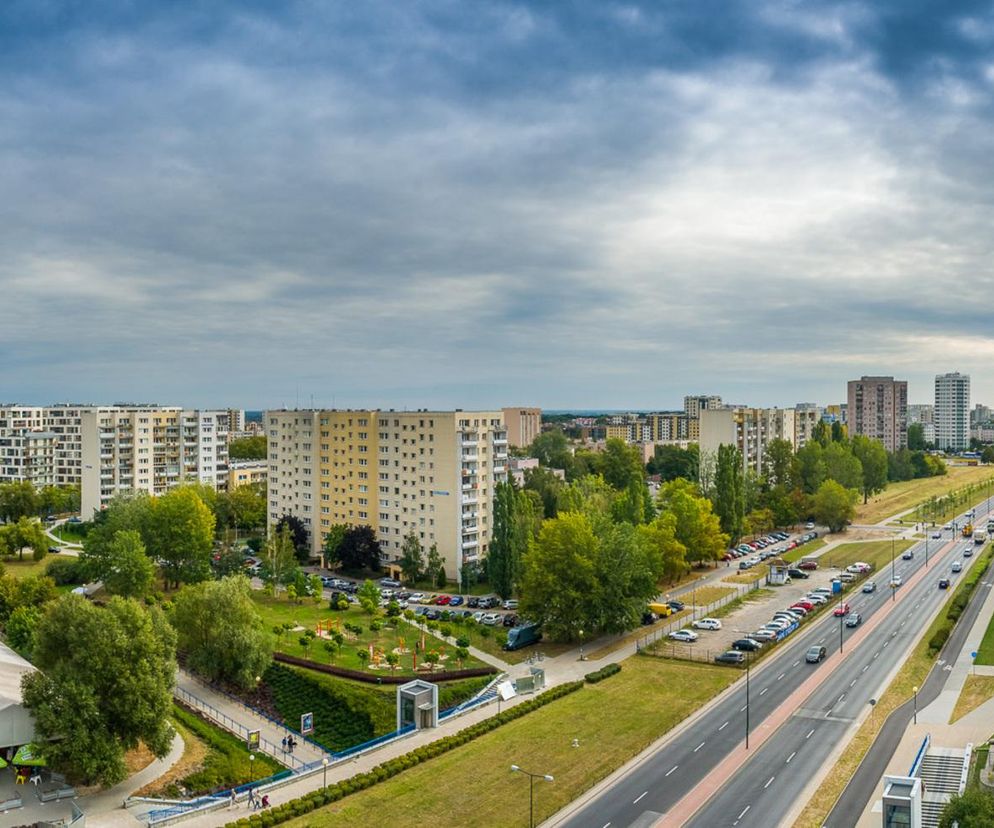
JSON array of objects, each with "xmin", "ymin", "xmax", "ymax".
[{"xmin": 21, "ymin": 594, "xmax": 176, "ymax": 785}]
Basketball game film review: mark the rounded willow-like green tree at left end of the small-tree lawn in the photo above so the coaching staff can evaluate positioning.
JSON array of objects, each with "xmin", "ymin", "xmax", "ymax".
[{"xmin": 171, "ymin": 575, "xmax": 273, "ymax": 689}]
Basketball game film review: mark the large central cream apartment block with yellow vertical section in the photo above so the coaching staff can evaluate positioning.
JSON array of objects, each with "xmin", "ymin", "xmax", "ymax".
[{"xmin": 264, "ymin": 410, "xmax": 508, "ymax": 581}]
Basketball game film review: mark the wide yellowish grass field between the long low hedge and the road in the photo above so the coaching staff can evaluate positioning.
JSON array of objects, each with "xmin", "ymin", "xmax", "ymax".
[{"xmin": 287, "ymin": 657, "xmax": 739, "ymax": 828}]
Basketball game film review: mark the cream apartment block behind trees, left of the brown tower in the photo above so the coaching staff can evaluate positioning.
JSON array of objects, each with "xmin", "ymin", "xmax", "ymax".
[{"xmin": 700, "ymin": 407, "xmax": 797, "ymax": 474}]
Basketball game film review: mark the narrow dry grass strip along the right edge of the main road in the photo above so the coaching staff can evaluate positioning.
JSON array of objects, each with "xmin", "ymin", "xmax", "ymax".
[{"xmin": 794, "ymin": 544, "xmax": 985, "ymax": 828}]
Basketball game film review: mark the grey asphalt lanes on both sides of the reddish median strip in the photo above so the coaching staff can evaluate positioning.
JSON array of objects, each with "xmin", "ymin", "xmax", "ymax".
[{"xmin": 561, "ymin": 501, "xmax": 986, "ymax": 828}]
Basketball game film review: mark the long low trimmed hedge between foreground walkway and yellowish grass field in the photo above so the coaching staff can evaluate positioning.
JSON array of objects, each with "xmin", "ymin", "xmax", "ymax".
[{"xmin": 228, "ymin": 681, "xmax": 583, "ymax": 828}]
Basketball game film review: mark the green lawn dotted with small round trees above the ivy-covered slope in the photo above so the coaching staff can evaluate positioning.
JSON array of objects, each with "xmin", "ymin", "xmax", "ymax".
[{"xmin": 252, "ymin": 590, "xmax": 485, "ymax": 675}]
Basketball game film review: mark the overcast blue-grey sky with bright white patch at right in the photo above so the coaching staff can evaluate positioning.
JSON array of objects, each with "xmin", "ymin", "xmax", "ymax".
[{"xmin": 0, "ymin": 0, "xmax": 994, "ymax": 408}]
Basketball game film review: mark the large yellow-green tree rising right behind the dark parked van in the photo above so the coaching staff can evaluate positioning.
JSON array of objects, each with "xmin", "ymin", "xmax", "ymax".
[{"xmin": 520, "ymin": 512, "xmax": 600, "ymax": 641}]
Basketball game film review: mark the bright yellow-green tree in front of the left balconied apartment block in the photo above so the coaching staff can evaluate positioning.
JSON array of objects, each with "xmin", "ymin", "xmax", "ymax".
[{"xmin": 142, "ymin": 486, "xmax": 214, "ymax": 586}]
